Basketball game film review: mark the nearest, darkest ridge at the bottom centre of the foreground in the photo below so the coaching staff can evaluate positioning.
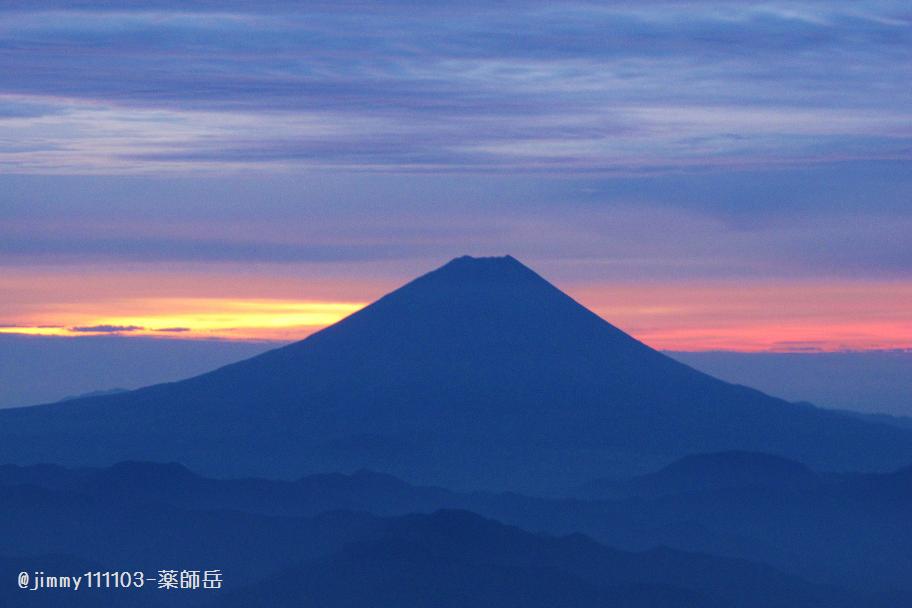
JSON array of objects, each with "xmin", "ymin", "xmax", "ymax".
[{"xmin": 214, "ymin": 511, "xmax": 844, "ymax": 608}]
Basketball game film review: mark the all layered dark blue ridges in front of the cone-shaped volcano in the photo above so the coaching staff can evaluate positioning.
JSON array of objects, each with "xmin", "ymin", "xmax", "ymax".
[{"xmin": 0, "ymin": 453, "xmax": 912, "ymax": 608}]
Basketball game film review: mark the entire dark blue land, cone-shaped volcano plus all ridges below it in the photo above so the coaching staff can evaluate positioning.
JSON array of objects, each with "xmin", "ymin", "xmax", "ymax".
[{"xmin": 0, "ymin": 257, "xmax": 912, "ymax": 608}]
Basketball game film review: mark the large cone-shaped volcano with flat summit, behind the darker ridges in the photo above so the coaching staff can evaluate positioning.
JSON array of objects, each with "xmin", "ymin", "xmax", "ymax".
[{"xmin": 0, "ymin": 256, "xmax": 912, "ymax": 492}]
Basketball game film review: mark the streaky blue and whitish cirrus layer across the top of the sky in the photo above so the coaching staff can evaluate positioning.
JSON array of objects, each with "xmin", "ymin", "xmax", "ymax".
[{"xmin": 0, "ymin": 2, "xmax": 912, "ymax": 172}]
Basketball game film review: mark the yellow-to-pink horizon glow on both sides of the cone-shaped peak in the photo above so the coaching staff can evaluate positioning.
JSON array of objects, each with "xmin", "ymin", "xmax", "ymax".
[{"xmin": 0, "ymin": 269, "xmax": 912, "ymax": 352}]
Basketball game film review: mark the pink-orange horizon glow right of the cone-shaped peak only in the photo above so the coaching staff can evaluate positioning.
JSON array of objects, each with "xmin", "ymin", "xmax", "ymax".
[{"xmin": 571, "ymin": 281, "xmax": 912, "ymax": 352}]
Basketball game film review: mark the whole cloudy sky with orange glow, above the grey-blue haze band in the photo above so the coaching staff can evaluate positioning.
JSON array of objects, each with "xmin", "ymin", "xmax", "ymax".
[{"xmin": 0, "ymin": 0, "xmax": 912, "ymax": 352}]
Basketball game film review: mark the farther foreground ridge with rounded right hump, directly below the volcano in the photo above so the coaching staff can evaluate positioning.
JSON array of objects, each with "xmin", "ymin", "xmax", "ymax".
[{"xmin": 0, "ymin": 452, "xmax": 912, "ymax": 592}]
